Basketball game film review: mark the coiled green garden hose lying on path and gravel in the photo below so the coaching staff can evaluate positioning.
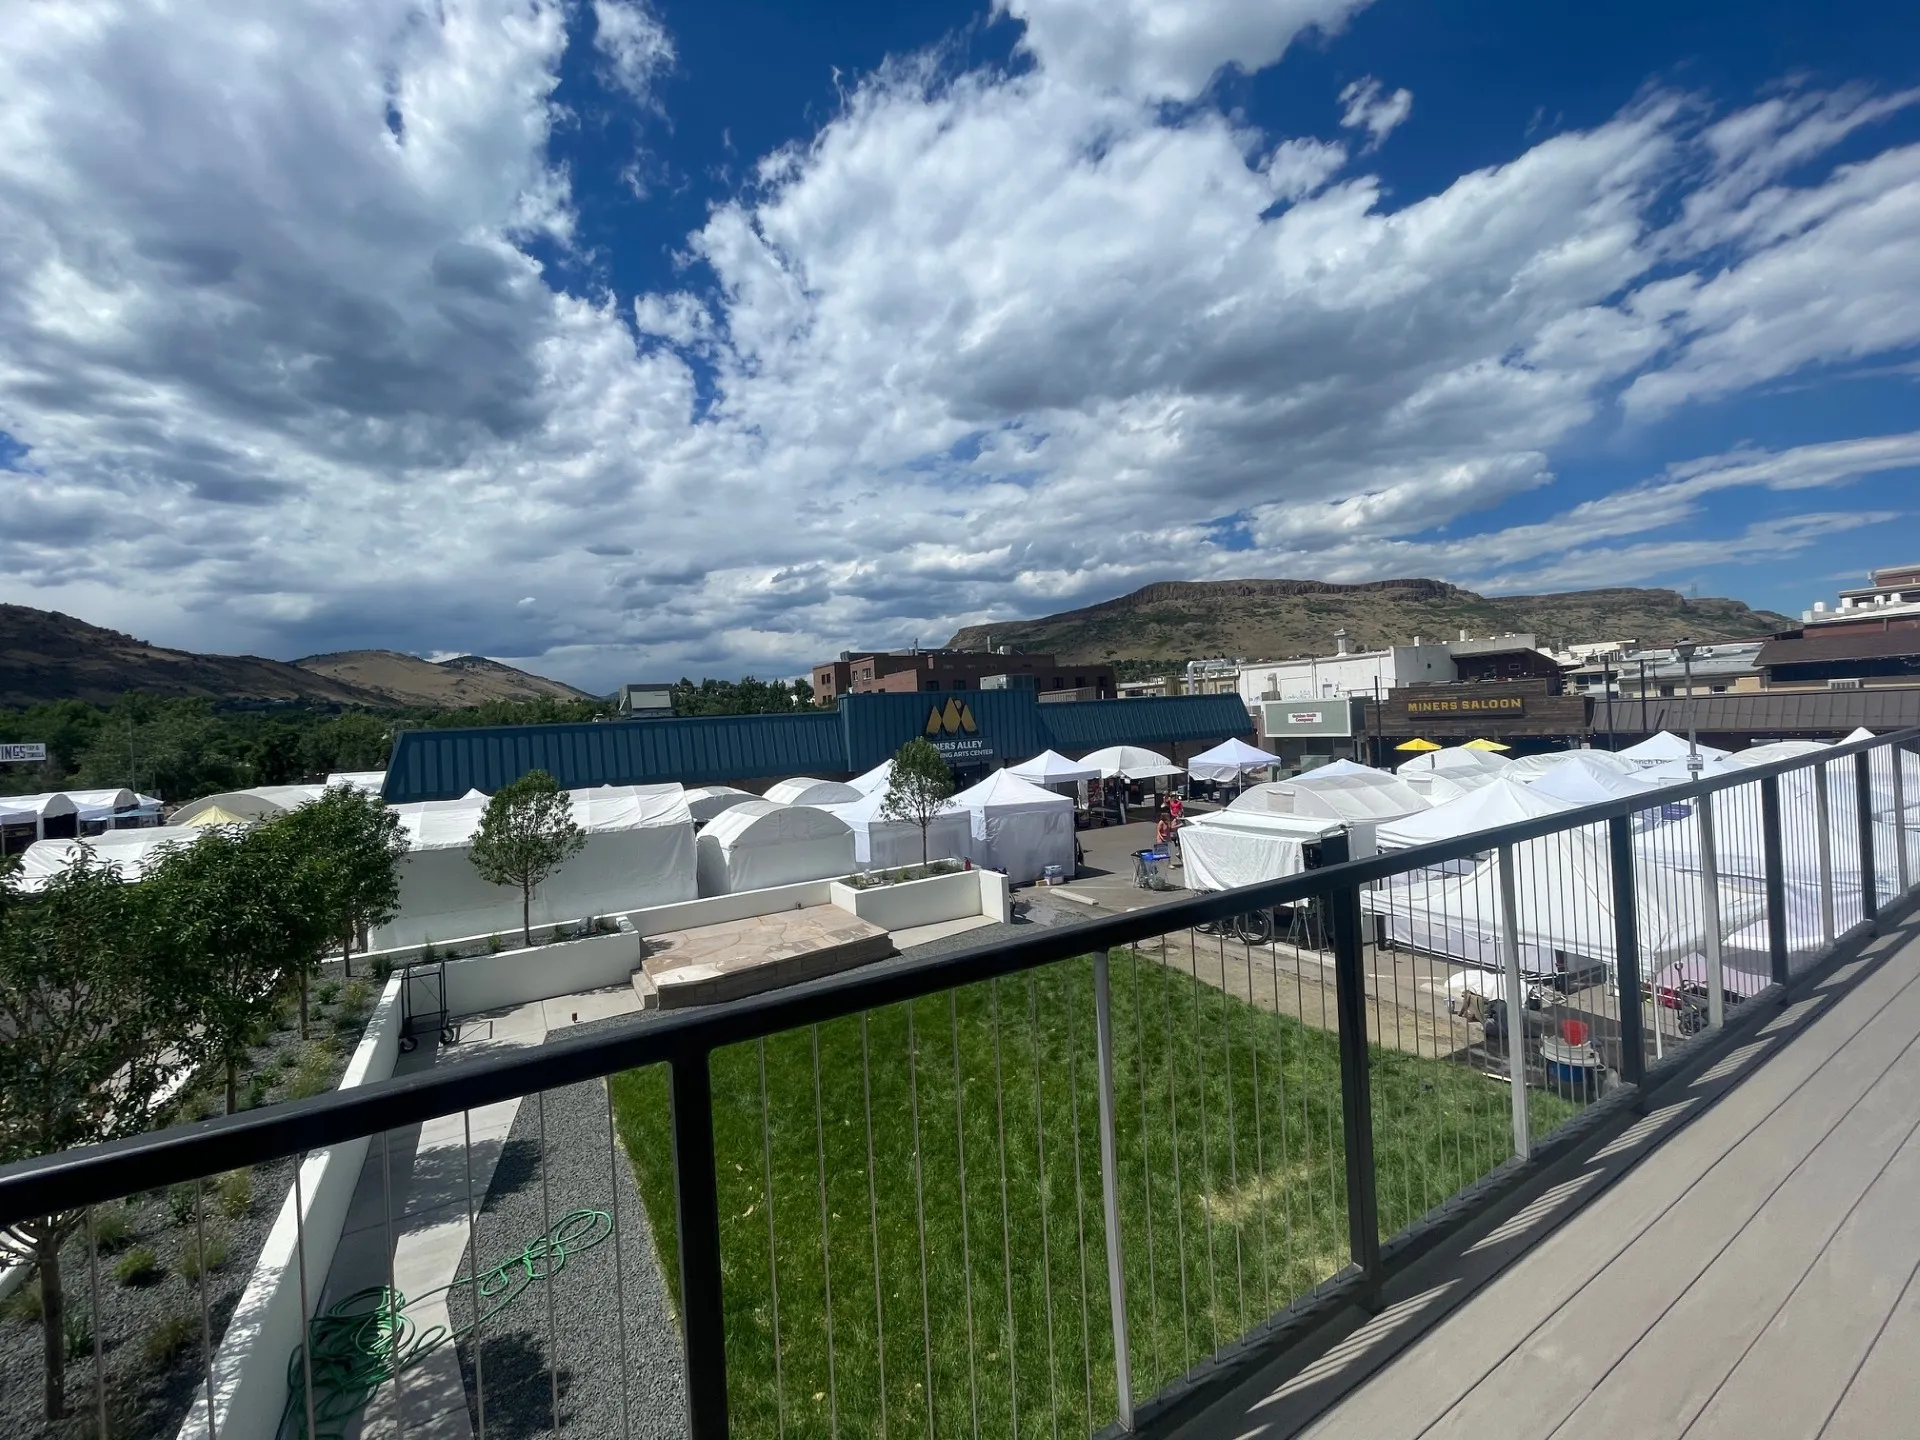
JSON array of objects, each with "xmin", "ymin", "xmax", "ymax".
[{"xmin": 282, "ymin": 1210, "xmax": 612, "ymax": 1440}]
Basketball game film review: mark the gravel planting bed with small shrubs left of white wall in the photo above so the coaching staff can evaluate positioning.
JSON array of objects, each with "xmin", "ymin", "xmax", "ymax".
[{"xmin": 0, "ymin": 962, "xmax": 372, "ymax": 1440}]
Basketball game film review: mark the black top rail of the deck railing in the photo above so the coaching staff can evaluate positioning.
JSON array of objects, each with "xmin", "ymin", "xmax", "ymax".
[{"xmin": 0, "ymin": 730, "xmax": 1920, "ymax": 1225}]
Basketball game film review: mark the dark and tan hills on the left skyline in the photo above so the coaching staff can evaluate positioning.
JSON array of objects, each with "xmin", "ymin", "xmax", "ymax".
[{"xmin": 0, "ymin": 605, "xmax": 580, "ymax": 708}]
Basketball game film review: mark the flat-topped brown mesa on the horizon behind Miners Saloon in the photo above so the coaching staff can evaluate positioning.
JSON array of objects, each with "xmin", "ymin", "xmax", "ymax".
[{"xmin": 948, "ymin": 580, "xmax": 1793, "ymax": 660}]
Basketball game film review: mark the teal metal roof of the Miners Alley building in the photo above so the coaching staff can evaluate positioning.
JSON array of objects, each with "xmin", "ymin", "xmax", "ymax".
[{"xmin": 386, "ymin": 689, "xmax": 1254, "ymax": 804}]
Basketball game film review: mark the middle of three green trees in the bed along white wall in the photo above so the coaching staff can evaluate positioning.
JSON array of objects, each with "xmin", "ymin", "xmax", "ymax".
[{"xmin": 142, "ymin": 824, "xmax": 328, "ymax": 1114}]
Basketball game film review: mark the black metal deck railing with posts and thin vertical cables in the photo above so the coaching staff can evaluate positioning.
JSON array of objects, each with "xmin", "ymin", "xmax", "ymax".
[{"xmin": 0, "ymin": 732, "xmax": 1920, "ymax": 1440}]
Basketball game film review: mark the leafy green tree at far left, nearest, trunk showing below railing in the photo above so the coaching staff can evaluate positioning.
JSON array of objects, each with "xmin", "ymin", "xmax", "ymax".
[{"xmin": 0, "ymin": 847, "xmax": 188, "ymax": 1421}]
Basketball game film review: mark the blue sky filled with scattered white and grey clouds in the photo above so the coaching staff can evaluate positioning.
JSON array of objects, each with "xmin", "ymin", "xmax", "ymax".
[{"xmin": 0, "ymin": 0, "xmax": 1920, "ymax": 687}]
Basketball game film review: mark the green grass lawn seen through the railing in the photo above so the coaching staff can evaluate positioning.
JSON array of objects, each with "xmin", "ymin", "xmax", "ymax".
[{"xmin": 612, "ymin": 952, "xmax": 1571, "ymax": 1436}]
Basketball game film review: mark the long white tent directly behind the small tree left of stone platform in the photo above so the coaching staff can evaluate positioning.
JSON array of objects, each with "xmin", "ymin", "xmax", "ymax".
[{"xmin": 372, "ymin": 785, "xmax": 697, "ymax": 948}]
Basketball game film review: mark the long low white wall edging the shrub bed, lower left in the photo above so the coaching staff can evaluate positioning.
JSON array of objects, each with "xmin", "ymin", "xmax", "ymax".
[{"xmin": 179, "ymin": 975, "xmax": 399, "ymax": 1440}]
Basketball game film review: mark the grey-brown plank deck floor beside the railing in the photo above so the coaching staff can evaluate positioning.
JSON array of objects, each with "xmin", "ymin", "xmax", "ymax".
[{"xmin": 1183, "ymin": 925, "xmax": 1920, "ymax": 1440}]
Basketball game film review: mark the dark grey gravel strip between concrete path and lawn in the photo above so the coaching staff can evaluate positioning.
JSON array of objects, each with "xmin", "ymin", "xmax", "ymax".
[{"xmin": 442, "ymin": 1018, "xmax": 685, "ymax": 1440}]
